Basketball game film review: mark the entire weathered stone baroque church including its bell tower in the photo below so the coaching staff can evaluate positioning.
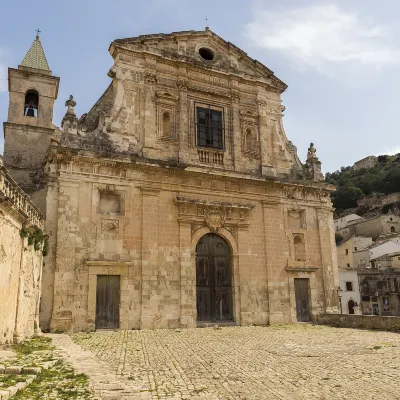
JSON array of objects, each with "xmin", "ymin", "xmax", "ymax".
[{"xmin": 4, "ymin": 28, "xmax": 338, "ymax": 331}]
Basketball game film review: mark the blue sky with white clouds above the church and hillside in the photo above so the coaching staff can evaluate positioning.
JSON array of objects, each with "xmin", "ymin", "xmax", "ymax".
[{"xmin": 0, "ymin": 0, "xmax": 400, "ymax": 172}]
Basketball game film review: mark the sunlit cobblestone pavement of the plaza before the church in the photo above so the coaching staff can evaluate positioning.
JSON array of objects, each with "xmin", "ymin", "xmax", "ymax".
[{"xmin": 51, "ymin": 324, "xmax": 400, "ymax": 400}]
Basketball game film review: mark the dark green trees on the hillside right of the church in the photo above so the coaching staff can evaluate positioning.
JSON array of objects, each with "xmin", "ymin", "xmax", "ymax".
[{"xmin": 325, "ymin": 154, "xmax": 400, "ymax": 210}]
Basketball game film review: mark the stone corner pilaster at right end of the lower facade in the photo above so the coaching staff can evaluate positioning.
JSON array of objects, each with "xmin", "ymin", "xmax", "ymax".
[{"xmin": 317, "ymin": 208, "xmax": 339, "ymax": 313}]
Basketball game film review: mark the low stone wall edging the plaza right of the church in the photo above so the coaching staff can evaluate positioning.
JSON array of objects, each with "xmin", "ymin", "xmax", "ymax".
[{"xmin": 315, "ymin": 314, "xmax": 400, "ymax": 331}]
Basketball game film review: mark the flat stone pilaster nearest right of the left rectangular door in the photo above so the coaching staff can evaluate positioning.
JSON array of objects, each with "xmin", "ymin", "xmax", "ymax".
[{"xmin": 140, "ymin": 187, "xmax": 162, "ymax": 329}]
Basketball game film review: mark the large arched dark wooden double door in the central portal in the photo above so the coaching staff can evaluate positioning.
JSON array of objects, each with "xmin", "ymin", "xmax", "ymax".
[{"xmin": 196, "ymin": 233, "xmax": 233, "ymax": 322}]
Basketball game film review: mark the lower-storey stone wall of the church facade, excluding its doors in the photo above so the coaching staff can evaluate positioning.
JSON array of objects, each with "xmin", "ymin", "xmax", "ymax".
[{"xmin": 46, "ymin": 154, "xmax": 338, "ymax": 331}]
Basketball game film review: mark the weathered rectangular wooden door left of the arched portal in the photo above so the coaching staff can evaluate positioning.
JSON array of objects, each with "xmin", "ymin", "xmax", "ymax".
[{"xmin": 96, "ymin": 275, "xmax": 120, "ymax": 329}]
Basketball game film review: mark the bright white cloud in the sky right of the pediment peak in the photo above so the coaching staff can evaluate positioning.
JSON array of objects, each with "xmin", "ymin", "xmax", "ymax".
[{"xmin": 246, "ymin": 4, "xmax": 400, "ymax": 72}]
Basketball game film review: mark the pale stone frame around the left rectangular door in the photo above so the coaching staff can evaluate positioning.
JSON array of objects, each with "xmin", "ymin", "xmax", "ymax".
[{"xmin": 85, "ymin": 261, "xmax": 132, "ymax": 330}]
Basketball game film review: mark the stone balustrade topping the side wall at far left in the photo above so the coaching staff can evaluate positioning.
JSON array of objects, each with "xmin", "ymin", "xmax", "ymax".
[{"xmin": 0, "ymin": 158, "xmax": 44, "ymax": 228}]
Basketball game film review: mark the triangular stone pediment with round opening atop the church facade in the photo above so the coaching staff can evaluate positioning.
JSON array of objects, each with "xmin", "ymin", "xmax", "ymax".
[{"xmin": 110, "ymin": 29, "xmax": 287, "ymax": 92}]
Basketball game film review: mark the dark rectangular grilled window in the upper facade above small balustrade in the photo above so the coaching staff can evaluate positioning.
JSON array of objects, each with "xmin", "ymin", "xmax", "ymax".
[{"xmin": 196, "ymin": 107, "xmax": 224, "ymax": 150}]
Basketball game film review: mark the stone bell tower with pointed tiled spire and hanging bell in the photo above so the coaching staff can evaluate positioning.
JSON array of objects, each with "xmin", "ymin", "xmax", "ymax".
[{"xmin": 3, "ymin": 30, "xmax": 60, "ymax": 187}]
